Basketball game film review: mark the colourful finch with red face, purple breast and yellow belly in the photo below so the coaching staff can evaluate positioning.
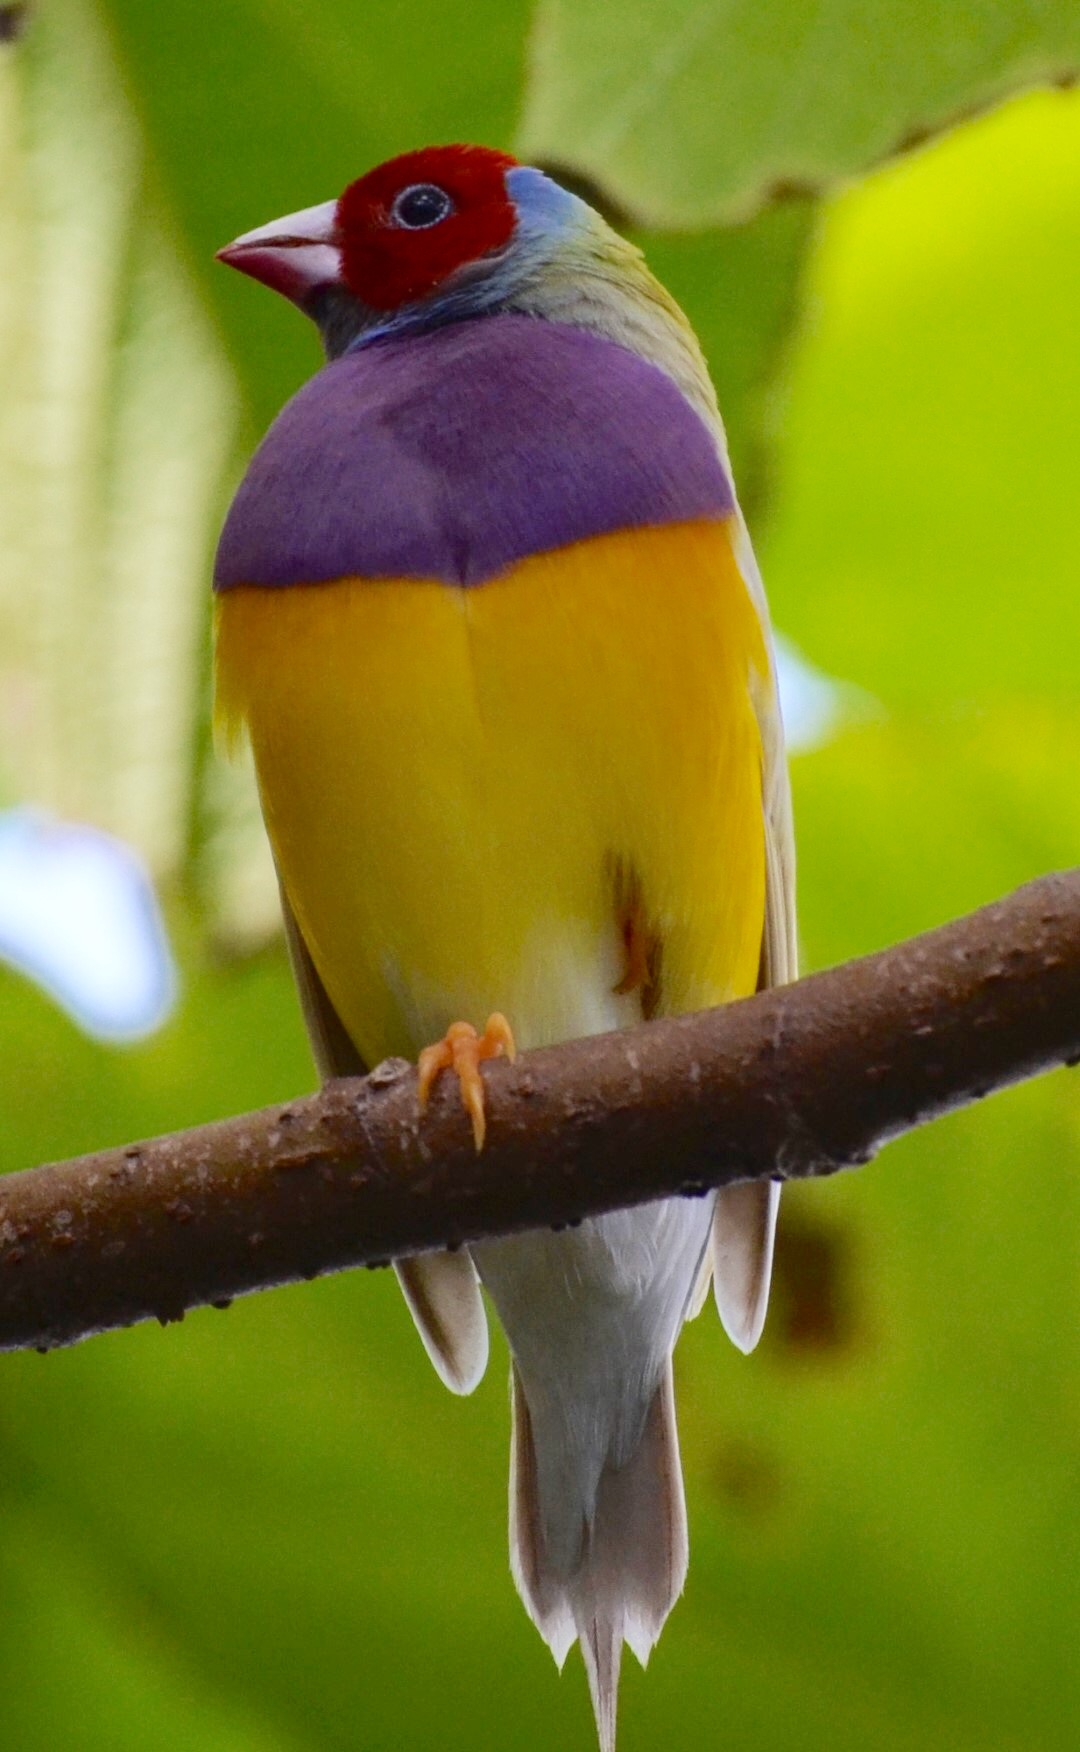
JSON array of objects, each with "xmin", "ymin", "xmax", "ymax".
[{"xmin": 214, "ymin": 145, "xmax": 796, "ymax": 1752}]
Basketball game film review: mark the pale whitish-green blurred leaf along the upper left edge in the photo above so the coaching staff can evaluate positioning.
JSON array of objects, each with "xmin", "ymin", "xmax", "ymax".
[{"xmin": 0, "ymin": 0, "xmax": 237, "ymax": 861}]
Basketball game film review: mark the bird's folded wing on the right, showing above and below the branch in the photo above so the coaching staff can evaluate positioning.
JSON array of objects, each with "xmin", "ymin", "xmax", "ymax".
[{"xmin": 708, "ymin": 534, "xmax": 798, "ymax": 1351}]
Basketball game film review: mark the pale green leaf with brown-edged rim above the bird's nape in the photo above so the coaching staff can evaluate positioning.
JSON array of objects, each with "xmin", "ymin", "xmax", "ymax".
[{"xmin": 521, "ymin": 0, "xmax": 1080, "ymax": 226}]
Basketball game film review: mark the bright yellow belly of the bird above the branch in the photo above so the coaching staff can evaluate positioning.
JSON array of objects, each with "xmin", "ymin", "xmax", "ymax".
[{"xmin": 217, "ymin": 524, "xmax": 766, "ymax": 1063}]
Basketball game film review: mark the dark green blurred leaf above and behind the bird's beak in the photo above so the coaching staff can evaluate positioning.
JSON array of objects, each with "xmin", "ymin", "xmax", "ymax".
[{"xmin": 100, "ymin": 0, "xmax": 528, "ymax": 431}]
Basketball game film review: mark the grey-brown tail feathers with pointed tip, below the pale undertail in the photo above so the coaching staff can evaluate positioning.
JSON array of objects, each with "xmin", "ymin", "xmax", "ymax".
[{"xmin": 510, "ymin": 1360, "xmax": 689, "ymax": 1752}]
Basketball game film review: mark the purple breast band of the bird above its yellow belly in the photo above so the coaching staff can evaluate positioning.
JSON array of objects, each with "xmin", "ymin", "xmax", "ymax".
[{"xmin": 214, "ymin": 315, "xmax": 733, "ymax": 589}]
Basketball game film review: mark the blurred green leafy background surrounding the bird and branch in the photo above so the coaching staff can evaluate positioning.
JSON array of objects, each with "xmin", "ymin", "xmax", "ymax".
[{"xmin": 0, "ymin": 0, "xmax": 1080, "ymax": 1752}]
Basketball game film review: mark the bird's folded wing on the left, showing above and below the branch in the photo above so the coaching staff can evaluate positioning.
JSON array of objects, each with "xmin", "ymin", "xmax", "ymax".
[{"xmin": 279, "ymin": 880, "xmax": 487, "ymax": 1393}]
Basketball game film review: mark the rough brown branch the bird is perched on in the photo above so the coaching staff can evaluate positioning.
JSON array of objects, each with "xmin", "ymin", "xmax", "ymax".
[{"xmin": 0, "ymin": 871, "xmax": 1080, "ymax": 1349}]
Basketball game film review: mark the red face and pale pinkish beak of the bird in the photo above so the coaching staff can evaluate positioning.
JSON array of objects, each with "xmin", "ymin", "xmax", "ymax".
[{"xmin": 219, "ymin": 145, "xmax": 515, "ymax": 312}]
